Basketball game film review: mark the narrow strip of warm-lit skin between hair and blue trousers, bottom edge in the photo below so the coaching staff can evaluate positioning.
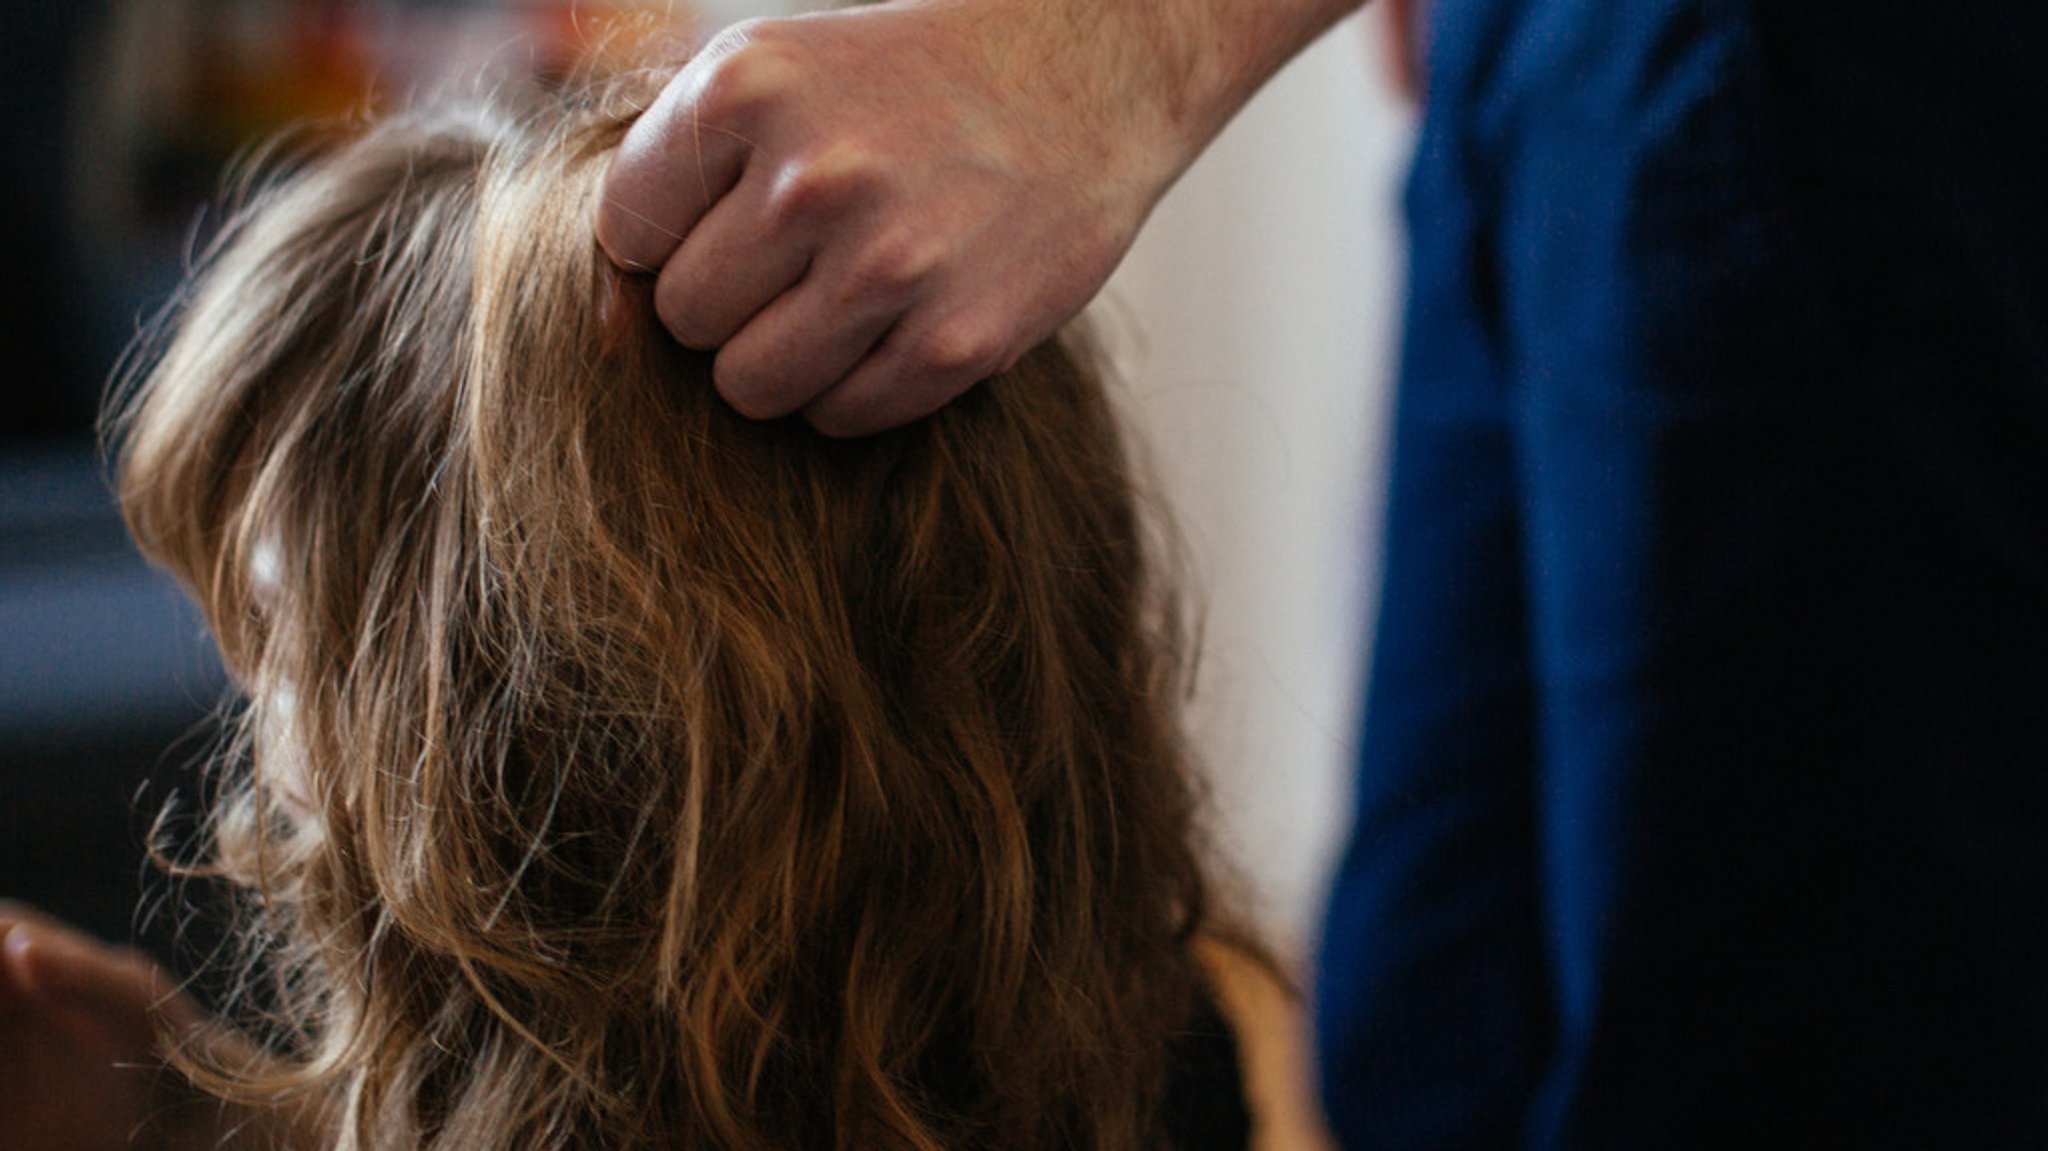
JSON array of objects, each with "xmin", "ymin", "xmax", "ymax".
[{"xmin": 1194, "ymin": 934, "xmax": 1335, "ymax": 1151}]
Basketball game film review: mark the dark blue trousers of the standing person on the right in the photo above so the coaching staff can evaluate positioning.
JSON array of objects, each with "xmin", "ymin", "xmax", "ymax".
[{"xmin": 1317, "ymin": 0, "xmax": 2048, "ymax": 1149}]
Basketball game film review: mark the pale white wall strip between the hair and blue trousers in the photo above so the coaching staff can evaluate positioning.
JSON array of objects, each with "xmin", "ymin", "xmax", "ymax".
[{"xmin": 1098, "ymin": 12, "xmax": 1409, "ymax": 956}]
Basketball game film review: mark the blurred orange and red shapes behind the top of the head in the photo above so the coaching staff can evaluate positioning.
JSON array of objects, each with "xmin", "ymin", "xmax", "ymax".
[{"xmin": 82, "ymin": 0, "xmax": 696, "ymax": 227}]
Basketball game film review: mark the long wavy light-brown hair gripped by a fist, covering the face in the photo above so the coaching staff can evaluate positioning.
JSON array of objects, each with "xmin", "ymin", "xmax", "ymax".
[{"xmin": 113, "ymin": 69, "xmax": 1204, "ymax": 1151}]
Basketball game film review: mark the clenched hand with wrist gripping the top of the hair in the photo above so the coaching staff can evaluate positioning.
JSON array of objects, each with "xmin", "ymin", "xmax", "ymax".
[{"xmin": 596, "ymin": 0, "xmax": 1358, "ymax": 434}]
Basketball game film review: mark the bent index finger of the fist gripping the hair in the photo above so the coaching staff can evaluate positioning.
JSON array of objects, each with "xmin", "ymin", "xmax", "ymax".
[{"xmin": 596, "ymin": 43, "xmax": 752, "ymax": 272}]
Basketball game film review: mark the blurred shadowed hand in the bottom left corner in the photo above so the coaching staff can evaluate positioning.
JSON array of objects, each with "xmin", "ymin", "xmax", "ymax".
[{"xmin": 0, "ymin": 901, "xmax": 203, "ymax": 1151}]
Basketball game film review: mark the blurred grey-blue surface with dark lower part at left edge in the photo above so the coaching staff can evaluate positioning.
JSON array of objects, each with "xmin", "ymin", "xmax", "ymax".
[{"xmin": 0, "ymin": 442, "xmax": 225, "ymax": 954}]
